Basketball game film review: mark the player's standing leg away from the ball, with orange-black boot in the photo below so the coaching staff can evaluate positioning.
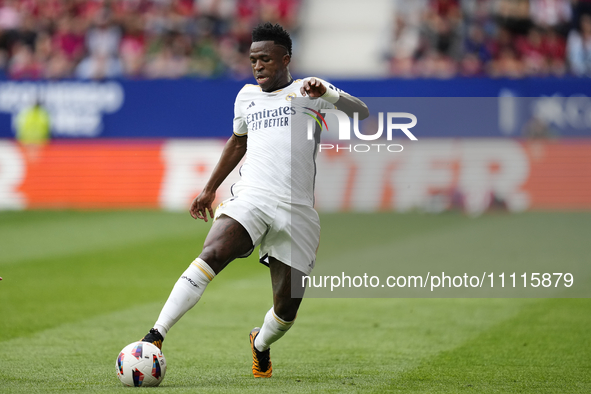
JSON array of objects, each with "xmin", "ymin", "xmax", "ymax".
[{"xmin": 250, "ymin": 257, "xmax": 304, "ymax": 378}]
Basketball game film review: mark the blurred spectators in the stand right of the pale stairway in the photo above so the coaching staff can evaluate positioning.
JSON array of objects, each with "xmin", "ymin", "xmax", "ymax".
[{"xmin": 394, "ymin": 0, "xmax": 591, "ymax": 78}]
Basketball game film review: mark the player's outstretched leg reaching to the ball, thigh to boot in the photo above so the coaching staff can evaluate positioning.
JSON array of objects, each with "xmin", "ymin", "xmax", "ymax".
[{"xmin": 142, "ymin": 215, "xmax": 253, "ymax": 348}]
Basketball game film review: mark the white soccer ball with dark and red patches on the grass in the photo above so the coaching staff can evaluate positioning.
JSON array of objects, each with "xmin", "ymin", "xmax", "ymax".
[{"xmin": 115, "ymin": 342, "xmax": 166, "ymax": 387}]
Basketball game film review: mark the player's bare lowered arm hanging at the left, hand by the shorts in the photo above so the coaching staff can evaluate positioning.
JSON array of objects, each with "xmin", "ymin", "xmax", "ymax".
[{"xmin": 189, "ymin": 134, "xmax": 248, "ymax": 222}]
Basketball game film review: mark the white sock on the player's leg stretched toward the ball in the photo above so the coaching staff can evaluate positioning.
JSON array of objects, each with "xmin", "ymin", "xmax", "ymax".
[{"xmin": 154, "ymin": 258, "xmax": 215, "ymax": 337}]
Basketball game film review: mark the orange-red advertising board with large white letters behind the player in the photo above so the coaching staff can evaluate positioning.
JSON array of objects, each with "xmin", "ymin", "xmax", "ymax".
[{"xmin": 0, "ymin": 139, "xmax": 591, "ymax": 213}]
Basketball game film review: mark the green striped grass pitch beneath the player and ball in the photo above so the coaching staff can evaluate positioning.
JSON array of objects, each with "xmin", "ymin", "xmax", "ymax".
[{"xmin": 0, "ymin": 211, "xmax": 591, "ymax": 393}]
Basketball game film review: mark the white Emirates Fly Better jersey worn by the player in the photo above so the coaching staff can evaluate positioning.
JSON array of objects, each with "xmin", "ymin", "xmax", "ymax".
[{"xmin": 233, "ymin": 79, "xmax": 336, "ymax": 206}]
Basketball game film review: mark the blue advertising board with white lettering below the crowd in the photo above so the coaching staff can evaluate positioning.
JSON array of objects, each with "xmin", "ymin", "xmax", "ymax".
[{"xmin": 0, "ymin": 78, "xmax": 591, "ymax": 138}]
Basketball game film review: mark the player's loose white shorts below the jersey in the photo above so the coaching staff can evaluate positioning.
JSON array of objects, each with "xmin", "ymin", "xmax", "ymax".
[{"xmin": 214, "ymin": 189, "xmax": 320, "ymax": 275}]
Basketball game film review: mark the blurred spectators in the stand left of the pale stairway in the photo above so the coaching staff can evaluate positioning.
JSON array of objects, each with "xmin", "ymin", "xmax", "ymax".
[{"xmin": 0, "ymin": 0, "xmax": 300, "ymax": 79}]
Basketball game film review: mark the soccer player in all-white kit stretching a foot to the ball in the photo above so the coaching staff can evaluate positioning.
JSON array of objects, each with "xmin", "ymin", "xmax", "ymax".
[{"xmin": 142, "ymin": 23, "xmax": 369, "ymax": 378}]
